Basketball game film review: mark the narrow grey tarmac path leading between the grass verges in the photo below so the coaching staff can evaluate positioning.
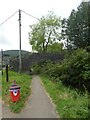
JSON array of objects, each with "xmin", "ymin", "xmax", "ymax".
[{"xmin": 2, "ymin": 76, "xmax": 58, "ymax": 118}]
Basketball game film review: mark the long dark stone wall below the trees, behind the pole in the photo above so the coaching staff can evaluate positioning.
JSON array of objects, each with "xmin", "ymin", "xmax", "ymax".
[{"xmin": 10, "ymin": 53, "xmax": 64, "ymax": 71}]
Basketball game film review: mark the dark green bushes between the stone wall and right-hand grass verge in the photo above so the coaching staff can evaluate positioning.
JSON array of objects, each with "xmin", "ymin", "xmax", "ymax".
[{"xmin": 32, "ymin": 49, "xmax": 90, "ymax": 91}]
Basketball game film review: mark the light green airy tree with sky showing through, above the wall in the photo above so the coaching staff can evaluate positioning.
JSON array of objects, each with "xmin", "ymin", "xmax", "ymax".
[{"xmin": 29, "ymin": 12, "xmax": 61, "ymax": 53}]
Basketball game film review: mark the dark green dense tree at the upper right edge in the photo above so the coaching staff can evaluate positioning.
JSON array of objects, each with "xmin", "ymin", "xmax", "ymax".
[{"xmin": 64, "ymin": 2, "xmax": 90, "ymax": 48}]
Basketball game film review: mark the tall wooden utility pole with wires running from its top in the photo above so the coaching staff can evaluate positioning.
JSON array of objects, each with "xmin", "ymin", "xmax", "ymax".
[{"xmin": 19, "ymin": 9, "xmax": 22, "ymax": 74}]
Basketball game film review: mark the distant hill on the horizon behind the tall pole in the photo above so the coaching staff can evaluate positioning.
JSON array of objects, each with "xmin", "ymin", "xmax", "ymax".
[{"xmin": 3, "ymin": 50, "xmax": 29, "ymax": 57}]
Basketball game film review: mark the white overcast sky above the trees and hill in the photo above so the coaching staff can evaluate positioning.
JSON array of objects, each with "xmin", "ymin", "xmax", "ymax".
[{"xmin": 0, "ymin": 0, "xmax": 82, "ymax": 51}]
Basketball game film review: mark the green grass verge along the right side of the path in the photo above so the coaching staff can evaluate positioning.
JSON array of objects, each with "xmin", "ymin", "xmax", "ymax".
[{"xmin": 41, "ymin": 76, "xmax": 88, "ymax": 118}]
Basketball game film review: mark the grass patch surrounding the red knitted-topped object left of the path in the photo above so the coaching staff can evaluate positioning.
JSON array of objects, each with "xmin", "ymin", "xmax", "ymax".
[{"xmin": 2, "ymin": 71, "xmax": 31, "ymax": 113}]
